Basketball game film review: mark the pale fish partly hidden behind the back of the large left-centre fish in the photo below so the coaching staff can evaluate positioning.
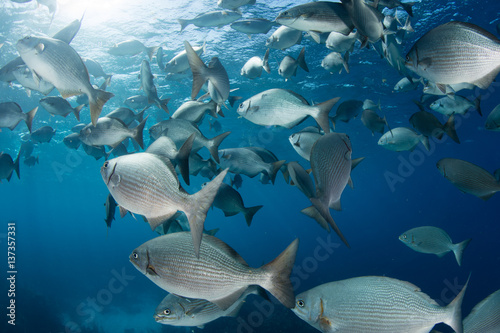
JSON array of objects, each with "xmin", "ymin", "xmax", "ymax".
[{"xmin": 146, "ymin": 133, "xmax": 196, "ymax": 185}]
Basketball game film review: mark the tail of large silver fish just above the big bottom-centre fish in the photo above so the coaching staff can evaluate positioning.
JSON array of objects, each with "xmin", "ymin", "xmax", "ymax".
[{"xmin": 184, "ymin": 169, "xmax": 228, "ymax": 257}]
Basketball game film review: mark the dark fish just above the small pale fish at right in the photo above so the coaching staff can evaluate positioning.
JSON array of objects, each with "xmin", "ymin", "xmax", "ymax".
[{"xmin": 410, "ymin": 109, "xmax": 460, "ymax": 143}]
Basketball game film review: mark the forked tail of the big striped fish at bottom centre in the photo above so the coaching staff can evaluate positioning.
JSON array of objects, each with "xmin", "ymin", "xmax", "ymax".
[{"xmin": 261, "ymin": 238, "xmax": 299, "ymax": 309}]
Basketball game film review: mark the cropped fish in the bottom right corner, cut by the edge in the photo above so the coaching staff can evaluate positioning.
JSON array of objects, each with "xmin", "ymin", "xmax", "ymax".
[{"xmin": 463, "ymin": 290, "xmax": 500, "ymax": 333}]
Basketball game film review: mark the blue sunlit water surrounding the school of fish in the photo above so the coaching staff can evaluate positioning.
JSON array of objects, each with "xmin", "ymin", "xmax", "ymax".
[{"xmin": 0, "ymin": 0, "xmax": 500, "ymax": 333}]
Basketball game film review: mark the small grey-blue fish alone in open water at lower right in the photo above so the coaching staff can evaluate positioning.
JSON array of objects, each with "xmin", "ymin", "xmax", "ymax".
[{"xmin": 399, "ymin": 226, "xmax": 471, "ymax": 266}]
